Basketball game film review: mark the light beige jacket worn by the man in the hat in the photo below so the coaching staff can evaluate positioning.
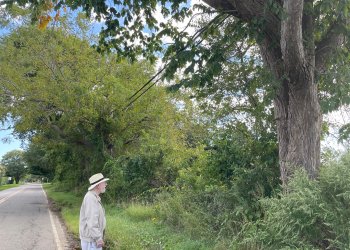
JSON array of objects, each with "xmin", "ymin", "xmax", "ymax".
[{"xmin": 79, "ymin": 190, "xmax": 106, "ymax": 242}]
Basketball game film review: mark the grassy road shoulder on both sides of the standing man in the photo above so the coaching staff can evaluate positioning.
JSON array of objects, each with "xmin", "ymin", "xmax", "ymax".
[{"xmin": 44, "ymin": 185, "xmax": 213, "ymax": 250}]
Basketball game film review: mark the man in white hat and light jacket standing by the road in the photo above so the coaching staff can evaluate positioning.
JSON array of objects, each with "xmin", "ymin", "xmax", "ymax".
[{"xmin": 79, "ymin": 173, "xmax": 109, "ymax": 250}]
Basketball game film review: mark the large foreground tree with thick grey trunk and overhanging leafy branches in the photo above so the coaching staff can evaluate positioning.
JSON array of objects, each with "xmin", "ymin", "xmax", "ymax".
[{"xmin": 5, "ymin": 0, "xmax": 350, "ymax": 184}]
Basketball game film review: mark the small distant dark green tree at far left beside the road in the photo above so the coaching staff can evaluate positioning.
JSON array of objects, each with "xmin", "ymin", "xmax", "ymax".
[{"xmin": 1, "ymin": 150, "xmax": 26, "ymax": 184}]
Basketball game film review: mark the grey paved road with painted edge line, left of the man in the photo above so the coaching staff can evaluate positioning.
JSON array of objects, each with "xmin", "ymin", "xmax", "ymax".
[{"xmin": 0, "ymin": 184, "xmax": 68, "ymax": 250}]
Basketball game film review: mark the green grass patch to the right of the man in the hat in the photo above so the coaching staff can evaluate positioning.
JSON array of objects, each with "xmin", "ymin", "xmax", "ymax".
[{"xmin": 106, "ymin": 204, "xmax": 210, "ymax": 250}]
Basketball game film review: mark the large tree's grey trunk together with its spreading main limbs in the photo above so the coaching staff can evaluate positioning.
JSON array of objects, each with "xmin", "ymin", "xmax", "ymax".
[{"xmin": 200, "ymin": 0, "xmax": 349, "ymax": 188}]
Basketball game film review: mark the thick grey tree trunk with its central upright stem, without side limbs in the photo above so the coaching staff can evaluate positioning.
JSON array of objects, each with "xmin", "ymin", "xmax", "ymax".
[{"xmin": 275, "ymin": 0, "xmax": 322, "ymax": 184}]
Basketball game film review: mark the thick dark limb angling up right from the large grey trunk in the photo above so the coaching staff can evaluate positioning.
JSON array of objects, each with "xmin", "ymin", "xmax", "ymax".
[{"xmin": 315, "ymin": 22, "xmax": 345, "ymax": 72}]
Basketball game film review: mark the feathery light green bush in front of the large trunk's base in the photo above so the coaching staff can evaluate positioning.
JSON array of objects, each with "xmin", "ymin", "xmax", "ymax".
[{"xmin": 240, "ymin": 155, "xmax": 350, "ymax": 249}]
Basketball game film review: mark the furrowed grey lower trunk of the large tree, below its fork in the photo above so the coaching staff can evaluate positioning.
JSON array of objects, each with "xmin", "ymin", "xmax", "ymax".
[{"xmin": 274, "ymin": 67, "xmax": 322, "ymax": 185}]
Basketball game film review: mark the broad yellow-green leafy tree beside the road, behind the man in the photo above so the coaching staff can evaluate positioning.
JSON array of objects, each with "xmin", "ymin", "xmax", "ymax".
[{"xmin": 0, "ymin": 26, "xmax": 200, "ymax": 191}]
